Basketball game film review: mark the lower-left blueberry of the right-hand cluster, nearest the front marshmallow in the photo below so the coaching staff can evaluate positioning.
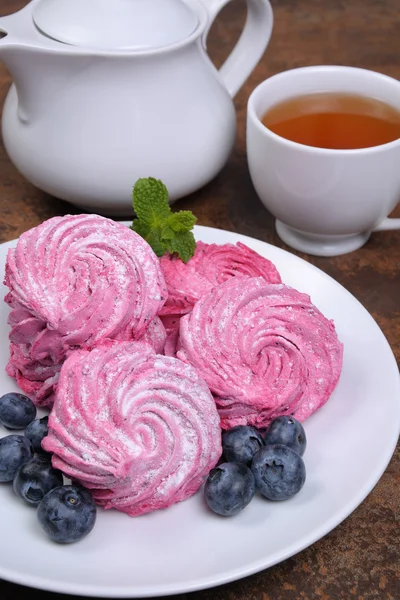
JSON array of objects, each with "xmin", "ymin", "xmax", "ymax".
[{"xmin": 204, "ymin": 462, "xmax": 255, "ymax": 517}]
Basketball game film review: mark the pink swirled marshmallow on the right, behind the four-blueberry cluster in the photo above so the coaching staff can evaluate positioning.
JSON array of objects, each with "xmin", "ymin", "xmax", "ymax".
[{"xmin": 177, "ymin": 276, "xmax": 343, "ymax": 429}]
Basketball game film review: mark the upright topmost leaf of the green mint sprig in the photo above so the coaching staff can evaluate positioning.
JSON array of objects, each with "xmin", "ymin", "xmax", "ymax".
[{"xmin": 133, "ymin": 177, "xmax": 171, "ymax": 228}]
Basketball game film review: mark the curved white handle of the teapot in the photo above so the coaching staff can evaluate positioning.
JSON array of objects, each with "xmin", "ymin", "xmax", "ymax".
[{"xmin": 201, "ymin": 0, "xmax": 274, "ymax": 98}]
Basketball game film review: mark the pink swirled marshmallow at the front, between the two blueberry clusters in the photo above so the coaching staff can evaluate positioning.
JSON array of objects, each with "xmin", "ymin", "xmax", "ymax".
[{"xmin": 43, "ymin": 342, "xmax": 221, "ymax": 515}]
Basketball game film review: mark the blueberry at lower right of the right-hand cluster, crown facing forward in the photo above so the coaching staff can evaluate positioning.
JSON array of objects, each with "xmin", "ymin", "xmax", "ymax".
[{"xmin": 251, "ymin": 444, "xmax": 306, "ymax": 500}]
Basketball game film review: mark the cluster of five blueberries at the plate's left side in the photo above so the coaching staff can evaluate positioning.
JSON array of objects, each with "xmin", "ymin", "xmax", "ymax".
[{"xmin": 0, "ymin": 392, "xmax": 96, "ymax": 544}]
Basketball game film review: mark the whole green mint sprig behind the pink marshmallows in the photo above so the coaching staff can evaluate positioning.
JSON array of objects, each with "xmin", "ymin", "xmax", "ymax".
[{"xmin": 131, "ymin": 177, "xmax": 197, "ymax": 263}]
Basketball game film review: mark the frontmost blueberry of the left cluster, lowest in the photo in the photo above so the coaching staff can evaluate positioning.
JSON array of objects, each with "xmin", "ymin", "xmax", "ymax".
[{"xmin": 37, "ymin": 485, "xmax": 97, "ymax": 544}]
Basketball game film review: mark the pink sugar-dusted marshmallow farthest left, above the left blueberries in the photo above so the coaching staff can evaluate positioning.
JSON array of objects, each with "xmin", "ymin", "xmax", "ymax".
[{"xmin": 5, "ymin": 215, "xmax": 167, "ymax": 405}]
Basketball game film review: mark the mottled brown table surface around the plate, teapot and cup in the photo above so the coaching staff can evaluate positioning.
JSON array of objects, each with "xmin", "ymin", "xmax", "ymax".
[{"xmin": 0, "ymin": 0, "xmax": 400, "ymax": 600}]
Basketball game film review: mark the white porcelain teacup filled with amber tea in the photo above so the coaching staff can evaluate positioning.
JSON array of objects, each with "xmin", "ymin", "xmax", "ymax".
[{"xmin": 246, "ymin": 65, "xmax": 400, "ymax": 256}]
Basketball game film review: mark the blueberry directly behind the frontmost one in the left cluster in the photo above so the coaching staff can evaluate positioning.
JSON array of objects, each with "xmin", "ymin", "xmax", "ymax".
[{"xmin": 13, "ymin": 456, "xmax": 64, "ymax": 506}]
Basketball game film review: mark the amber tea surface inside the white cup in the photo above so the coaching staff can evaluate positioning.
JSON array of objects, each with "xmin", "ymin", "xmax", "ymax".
[{"xmin": 261, "ymin": 92, "xmax": 400, "ymax": 150}]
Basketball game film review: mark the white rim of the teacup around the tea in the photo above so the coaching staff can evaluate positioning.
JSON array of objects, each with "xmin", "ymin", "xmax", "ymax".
[{"xmin": 247, "ymin": 65, "xmax": 400, "ymax": 156}]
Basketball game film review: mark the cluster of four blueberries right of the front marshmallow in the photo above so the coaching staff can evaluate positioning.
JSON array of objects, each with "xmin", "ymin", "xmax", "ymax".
[{"xmin": 204, "ymin": 416, "xmax": 307, "ymax": 517}]
